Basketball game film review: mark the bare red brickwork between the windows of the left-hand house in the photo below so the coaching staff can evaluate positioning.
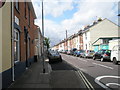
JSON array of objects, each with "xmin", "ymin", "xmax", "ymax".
[{"xmin": 14, "ymin": 2, "xmax": 36, "ymax": 61}]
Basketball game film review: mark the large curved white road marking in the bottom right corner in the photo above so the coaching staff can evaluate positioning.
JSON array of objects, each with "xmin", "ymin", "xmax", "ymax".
[{"xmin": 95, "ymin": 76, "xmax": 120, "ymax": 88}]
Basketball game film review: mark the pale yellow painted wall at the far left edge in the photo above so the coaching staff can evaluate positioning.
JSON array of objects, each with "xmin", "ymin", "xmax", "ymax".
[{"xmin": 0, "ymin": 2, "xmax": 11, "ymax": 72}]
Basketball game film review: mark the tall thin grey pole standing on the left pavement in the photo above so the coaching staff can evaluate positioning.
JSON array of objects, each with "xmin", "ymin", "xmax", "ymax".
[{"xmin": 42, "ymin": 0, "xmax": 45, "ymax": 73}]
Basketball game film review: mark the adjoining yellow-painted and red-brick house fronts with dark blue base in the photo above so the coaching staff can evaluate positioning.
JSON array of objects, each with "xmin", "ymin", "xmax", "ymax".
[{"xmin": 0, "ymin": 0, "xmax": 37, "ymax": 88}]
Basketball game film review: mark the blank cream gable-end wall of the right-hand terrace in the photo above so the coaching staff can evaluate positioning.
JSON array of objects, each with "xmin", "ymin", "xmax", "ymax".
[{"xmin": 88, "ymin": 19, "xmax": 118, "ymax": 49}]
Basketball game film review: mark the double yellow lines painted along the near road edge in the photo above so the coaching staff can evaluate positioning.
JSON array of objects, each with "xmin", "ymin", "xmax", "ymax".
[{"xmin": 77, "ymin": 70, "xmax": 95, "ymax": 90}]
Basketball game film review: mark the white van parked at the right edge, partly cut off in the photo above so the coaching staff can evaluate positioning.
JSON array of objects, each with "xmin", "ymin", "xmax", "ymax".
[{"xmin": 111, "ymin": 45, "xmax": 120, "ymax": 64}]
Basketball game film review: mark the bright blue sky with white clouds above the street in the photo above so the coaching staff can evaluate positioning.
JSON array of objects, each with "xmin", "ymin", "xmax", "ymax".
[{"xmin": 32, "ymin": 0, "xmax": 119, "ymax": 46}]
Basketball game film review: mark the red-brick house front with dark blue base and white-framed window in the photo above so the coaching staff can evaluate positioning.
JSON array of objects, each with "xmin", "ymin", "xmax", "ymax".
[{"xmin": 14, "ymin": 2, "xmax": 37, "ymax": 79}]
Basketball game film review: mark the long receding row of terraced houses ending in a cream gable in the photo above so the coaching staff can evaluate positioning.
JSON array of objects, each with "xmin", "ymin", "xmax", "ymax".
[{"xmin": 52, "ymin": 18, "xmax": 120, "ymax": 51}]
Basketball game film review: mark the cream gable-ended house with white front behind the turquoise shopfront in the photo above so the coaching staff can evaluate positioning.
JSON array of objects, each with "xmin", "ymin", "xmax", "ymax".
[{"xmin": 83, "ymin": 19, "xmax": 119, "ymax": 51}]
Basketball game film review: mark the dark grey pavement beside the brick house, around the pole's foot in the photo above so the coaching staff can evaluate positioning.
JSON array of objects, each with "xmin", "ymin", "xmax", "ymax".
[{"xmin": 9, "ymin": 57, "xmax": 50, "ymax": 88}]
